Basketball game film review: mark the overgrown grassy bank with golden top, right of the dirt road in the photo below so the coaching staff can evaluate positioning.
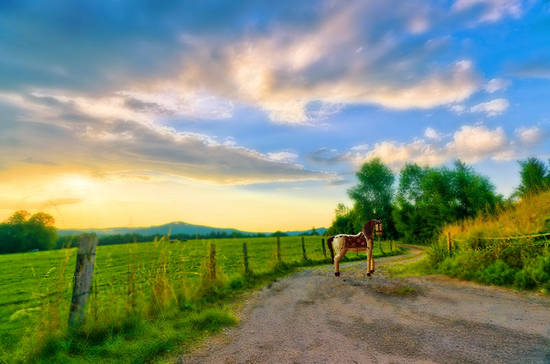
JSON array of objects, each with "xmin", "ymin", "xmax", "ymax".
[{"xmin": 429, "ymin": 192, "xmax": 550, "ymax": 292}]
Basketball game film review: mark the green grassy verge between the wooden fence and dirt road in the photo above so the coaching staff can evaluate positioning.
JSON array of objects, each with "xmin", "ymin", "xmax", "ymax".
[{"xmin": 0, "ymin": 240, "xmax": 400, "ymax": 363}]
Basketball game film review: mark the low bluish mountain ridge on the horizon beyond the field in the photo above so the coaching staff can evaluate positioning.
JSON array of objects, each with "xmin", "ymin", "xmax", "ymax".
[{"xmin": 58, "ymin": 221, "xmax": 326, "ymax": 236}]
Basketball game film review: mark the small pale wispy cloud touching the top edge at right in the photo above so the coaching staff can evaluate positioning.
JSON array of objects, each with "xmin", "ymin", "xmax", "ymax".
[{"xmin": 453, "ymin": 0, "xmax": 522, "ymax": 23}]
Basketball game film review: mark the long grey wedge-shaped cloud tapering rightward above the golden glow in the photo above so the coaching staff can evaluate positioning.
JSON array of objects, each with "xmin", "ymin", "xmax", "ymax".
[{"xmin": 0, "ymin": 94, "xmax": 334, "ymax": 184}]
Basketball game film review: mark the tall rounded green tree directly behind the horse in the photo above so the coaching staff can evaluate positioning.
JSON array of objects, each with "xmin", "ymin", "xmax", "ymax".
[{"xmin": 348, "ymin": 158, "xmax": 395, "ymax": 237}]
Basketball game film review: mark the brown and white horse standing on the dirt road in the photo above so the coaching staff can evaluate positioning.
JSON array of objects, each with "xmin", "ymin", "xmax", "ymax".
[{"xmin": 327, "ymin": 220, "xmax": 382, "ymax": 277}]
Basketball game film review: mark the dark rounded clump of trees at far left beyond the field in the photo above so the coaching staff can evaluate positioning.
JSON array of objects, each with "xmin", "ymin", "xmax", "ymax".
[{"xmin": 0, "ymin": 210, "xmax": 57, "ymax": 253}]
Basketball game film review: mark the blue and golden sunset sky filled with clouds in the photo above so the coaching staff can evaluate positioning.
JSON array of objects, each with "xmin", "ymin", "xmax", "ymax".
[{"xmin": 0, "ymin": 0, "xmax": 550, "ymax": 231}]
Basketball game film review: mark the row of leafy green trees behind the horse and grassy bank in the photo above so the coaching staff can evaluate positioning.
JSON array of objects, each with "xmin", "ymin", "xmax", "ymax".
[{"xmin": 325, "ymin": 158, "xmax": 550, "ymax": 243}]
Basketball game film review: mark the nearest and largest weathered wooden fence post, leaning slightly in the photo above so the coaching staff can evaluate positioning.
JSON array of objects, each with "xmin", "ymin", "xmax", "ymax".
[{"xmin": 69, "ymin": 234, "xmax": 97, "ymax": 328}]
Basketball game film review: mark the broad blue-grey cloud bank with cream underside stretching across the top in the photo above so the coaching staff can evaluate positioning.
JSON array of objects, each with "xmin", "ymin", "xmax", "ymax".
[{"xmin": 0, "ymin": 0, "xmax": 521, "ymax": 123}]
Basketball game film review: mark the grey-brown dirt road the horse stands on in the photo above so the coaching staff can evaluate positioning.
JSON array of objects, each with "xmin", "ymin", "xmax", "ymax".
[{"xmin": 180, "ymin": 249, "xmax": 550, "ymax": 364}]
